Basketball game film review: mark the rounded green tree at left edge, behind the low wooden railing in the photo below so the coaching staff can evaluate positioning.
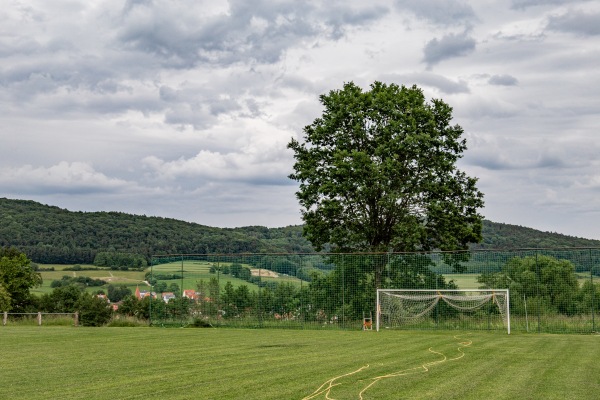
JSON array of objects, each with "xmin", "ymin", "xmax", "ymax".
[{"xmin": 0, "ymin": 247, "xmax": 42, "ymax": 312}]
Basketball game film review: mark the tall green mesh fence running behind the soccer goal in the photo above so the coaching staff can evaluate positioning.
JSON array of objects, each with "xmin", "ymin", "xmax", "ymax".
[{"xmin": 148, "ymin": 248, "xmax": 600, "ymax": 333}]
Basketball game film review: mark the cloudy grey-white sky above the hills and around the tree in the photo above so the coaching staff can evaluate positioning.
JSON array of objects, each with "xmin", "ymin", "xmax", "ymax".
[{"xmin": 0, "ymin": 0, "xmax": 600, "ymax": 239}]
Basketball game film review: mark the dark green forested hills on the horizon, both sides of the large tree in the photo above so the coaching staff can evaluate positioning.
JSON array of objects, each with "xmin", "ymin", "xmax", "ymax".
[{"xmin": 0, "ymin": 198, "xmax": 600, "ymax": 264}]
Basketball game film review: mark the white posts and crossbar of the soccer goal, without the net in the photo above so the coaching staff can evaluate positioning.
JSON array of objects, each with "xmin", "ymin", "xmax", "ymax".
[{"xmin": 375, "ymin": 289, "xmax": 510, "ymax": 335}]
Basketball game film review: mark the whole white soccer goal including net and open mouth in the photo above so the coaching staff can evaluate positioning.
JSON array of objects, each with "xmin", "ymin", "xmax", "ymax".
[{"xmin": 375, "ymin": 289, "xmax": 510, "ymax": 334}]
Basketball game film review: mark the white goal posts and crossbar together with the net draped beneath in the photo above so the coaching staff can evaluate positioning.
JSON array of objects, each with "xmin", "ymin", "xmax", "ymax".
[{"xmin": 375, "ymin": 289, "xmax": 510, "ymax": 334}]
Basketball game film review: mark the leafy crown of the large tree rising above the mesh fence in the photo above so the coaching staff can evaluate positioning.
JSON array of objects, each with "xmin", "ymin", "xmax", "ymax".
[{"xmin": 288, "ymin": 82, "xmax": 483, "ymax": 286}]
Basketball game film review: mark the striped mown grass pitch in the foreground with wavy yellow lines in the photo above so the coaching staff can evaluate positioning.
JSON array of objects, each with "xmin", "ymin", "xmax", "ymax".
[{"xmin": 0, "ymin": 326, "xmax": 600, "ymax": 400}]
